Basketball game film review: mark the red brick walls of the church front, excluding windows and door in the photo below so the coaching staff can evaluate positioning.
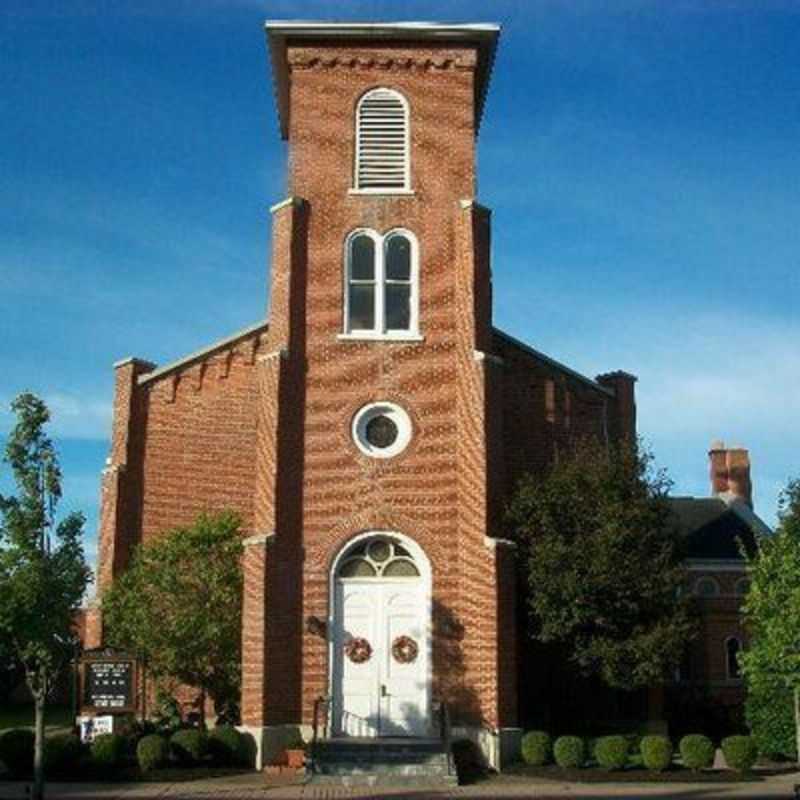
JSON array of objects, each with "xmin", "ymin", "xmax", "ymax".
[{"xmin": 97, "ymin": 32, "xmax": 610, "ymax": 726}]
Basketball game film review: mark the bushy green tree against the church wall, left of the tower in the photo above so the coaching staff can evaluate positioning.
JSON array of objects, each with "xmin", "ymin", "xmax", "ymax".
[{"xmin": 103, "ymin": 512, "xmax": 242, "ymax": 722}]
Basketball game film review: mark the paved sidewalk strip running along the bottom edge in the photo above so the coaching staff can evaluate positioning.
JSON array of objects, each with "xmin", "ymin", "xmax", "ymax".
[{"xmin": 0, "ymin": 773, "xmax": 800, "ymax": 800}]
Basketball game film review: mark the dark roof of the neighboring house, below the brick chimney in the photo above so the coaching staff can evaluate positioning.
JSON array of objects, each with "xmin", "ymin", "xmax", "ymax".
[{"xmin": 669, "ymin": 497, "xmax": 759, "ymax": 560}]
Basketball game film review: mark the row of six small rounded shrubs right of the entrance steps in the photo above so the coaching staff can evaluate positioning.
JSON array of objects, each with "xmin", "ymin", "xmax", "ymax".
[{"xmin": 522, "ymin": 731, "xmax": 758, "ymax": 772}]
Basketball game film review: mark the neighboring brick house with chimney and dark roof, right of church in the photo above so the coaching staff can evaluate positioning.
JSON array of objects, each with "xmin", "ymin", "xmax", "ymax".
[{"xmin": 671, "ymin": 441, "xmax": 769, "ymax": 706}]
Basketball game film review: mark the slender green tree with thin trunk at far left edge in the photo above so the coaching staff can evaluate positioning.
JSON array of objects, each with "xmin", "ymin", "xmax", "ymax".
[{"xmin": 0, "ymin": 393, "xmax": 91, "ymax": 799}]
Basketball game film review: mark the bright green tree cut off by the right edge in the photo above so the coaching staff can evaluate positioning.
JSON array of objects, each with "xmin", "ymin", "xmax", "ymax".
[{"xmin": 740, "ymin": 479, "xmax": 800, "ymax": 757}]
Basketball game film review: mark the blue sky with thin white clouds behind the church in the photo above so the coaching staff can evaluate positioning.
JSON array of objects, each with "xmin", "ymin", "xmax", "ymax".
[{"xmin": 0, "ymin": 0, "xmax": 800, "ymax": 576}]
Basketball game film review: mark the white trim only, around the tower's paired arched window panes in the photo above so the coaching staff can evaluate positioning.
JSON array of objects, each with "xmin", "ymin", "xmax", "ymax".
[{"xmin": 337, "ymin": 228, "xmax": 424, "ymax": 342}]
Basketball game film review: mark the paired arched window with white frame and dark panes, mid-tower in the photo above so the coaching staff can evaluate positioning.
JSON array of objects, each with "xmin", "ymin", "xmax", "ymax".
[{"xmin": 340, "ymin": 228, "xmax": 422, "ymax": 341}]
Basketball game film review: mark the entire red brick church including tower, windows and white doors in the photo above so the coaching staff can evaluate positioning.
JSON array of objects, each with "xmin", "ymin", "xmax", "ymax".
[{"xmin": 87, "ymin": 22, "xmax": 764, "ymax": 764}]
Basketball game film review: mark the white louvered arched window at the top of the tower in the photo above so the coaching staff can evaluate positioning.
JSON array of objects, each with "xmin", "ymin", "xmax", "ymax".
[{"xmin": 355, "ymin": 89, "xmax": 411, "ymax": 194}]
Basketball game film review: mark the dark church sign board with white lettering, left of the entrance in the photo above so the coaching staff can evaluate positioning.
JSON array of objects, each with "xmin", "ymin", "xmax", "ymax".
[{"xmin": 81, "ymin": 648, "xmax": 136, "ymax": 714}]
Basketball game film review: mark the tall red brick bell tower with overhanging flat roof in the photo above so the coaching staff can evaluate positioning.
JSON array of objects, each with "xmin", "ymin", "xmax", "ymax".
[{"xmin": 242, "ymin": 22, "xmax": 516, "ymax": 758}]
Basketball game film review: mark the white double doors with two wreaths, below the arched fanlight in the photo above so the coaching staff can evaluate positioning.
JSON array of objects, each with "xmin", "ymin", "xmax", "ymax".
[{"xmin": 332, "ymin": 578, "xmax": 431, "ymax": 736}]
